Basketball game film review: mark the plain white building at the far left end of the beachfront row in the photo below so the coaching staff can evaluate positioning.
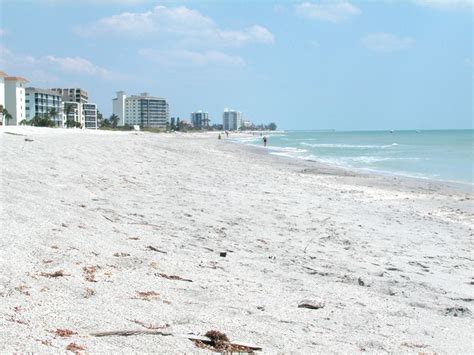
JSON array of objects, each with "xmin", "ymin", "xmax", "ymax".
[{"xmin": 4, "ymin": 76, "xmax": 28, "ymax": 125}]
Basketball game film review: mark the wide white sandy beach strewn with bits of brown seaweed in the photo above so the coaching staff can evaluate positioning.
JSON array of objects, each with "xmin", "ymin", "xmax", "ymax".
[{"xmin": 0, "ymin": 127, "xmax": 474, "ymax": 354}]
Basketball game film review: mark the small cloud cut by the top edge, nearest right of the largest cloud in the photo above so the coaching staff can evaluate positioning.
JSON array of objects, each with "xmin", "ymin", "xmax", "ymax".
[{"xmin": 295, "ymin": 1, "xmax": 361, "ymax": 23}]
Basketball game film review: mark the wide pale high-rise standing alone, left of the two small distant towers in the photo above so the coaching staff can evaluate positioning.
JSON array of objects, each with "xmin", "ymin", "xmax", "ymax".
[{"xmin": 112, "ymin": 91, "xmax": 169, "ymax": 128}]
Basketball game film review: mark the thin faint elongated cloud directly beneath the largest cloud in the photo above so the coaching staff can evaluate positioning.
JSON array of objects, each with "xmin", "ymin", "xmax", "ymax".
[{"xmin": 139, "ymin": 48, "xmax": 245, "ymax": 66}]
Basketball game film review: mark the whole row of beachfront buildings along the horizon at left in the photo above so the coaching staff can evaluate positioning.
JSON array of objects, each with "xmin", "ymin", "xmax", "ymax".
[{"xmin": 0, "ymin": 71, "xmax": 252, "ymax": 130}]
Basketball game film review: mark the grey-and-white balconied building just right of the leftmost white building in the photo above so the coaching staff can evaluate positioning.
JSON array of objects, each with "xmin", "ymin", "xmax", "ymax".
[{"xmin": 25, "ymin": 87, "xmax": 62, "ymax": 126}]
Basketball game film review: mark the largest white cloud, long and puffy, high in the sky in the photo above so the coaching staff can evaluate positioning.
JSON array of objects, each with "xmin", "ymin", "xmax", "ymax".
[{"xmin": 76, "ymin": 6, "xmax": 275, "ymax": 47}]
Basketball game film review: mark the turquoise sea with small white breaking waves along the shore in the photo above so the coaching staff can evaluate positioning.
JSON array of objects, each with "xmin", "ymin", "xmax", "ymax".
[{"xmin": 239, "ymin": 130, "xmax": 474, "ymax": 184}]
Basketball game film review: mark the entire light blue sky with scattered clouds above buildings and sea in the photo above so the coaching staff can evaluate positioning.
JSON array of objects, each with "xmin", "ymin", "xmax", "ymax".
[{"xmin": 0, "ymin": 0, "xmax": 474, "ymax": 130}]
